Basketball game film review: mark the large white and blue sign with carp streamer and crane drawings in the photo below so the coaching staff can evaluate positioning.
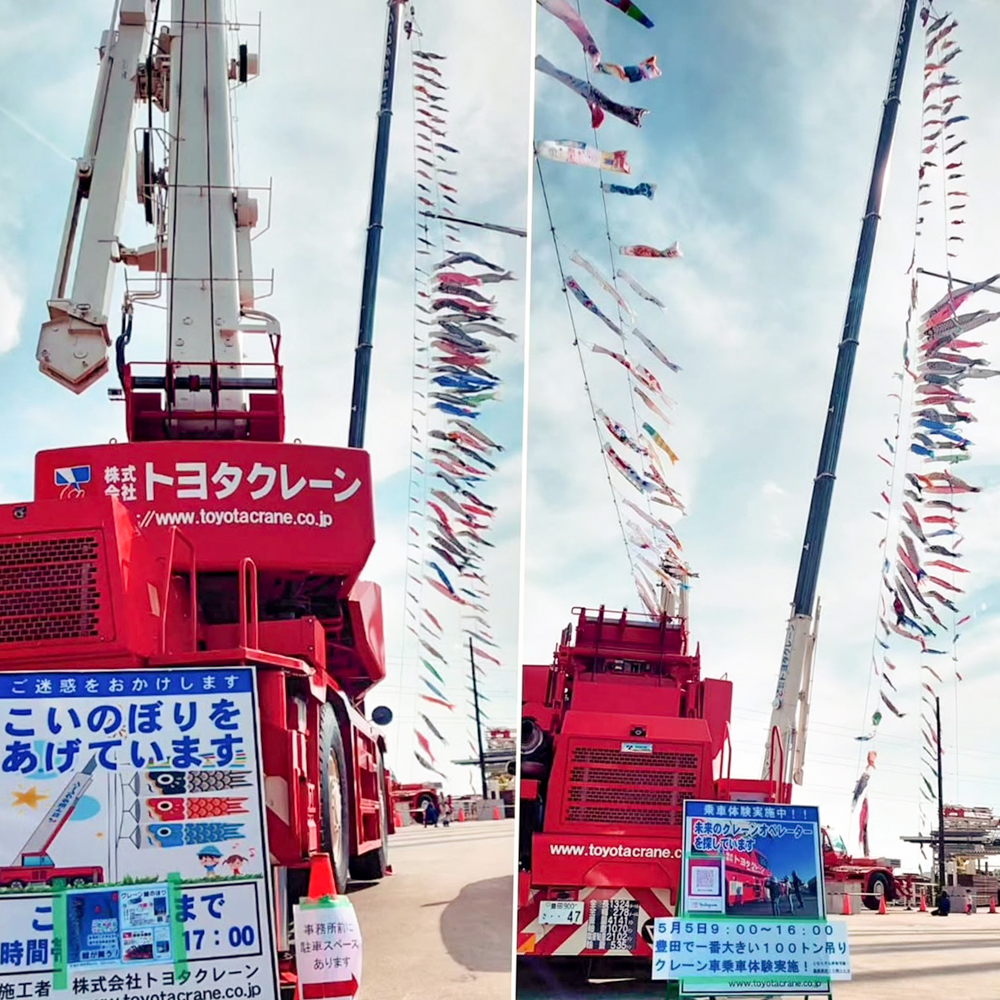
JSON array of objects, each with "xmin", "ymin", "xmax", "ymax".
[{"xmin": 0, "ymin": 667, "xmax": 278, "ymax": 1000}]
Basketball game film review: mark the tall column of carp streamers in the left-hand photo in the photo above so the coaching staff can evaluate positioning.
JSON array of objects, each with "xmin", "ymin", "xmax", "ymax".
[{"xmin": 404, "ymin": 29, "xmax": 520, "ymax": 776}]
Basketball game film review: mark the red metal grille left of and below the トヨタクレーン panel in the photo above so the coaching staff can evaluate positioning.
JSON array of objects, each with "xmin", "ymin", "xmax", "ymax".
[{"xmin": 0, "ymin": 536, "xmax": 101, "ymax": 645}]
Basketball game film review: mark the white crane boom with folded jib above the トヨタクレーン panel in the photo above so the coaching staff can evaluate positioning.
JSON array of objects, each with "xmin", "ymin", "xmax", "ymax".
[{"xmin": 37, "ymin": 0, "xmax": 268, "ymax": 438}]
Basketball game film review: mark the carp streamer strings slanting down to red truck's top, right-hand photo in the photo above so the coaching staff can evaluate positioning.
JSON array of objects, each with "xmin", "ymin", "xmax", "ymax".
[{"xmin": 535, "ymin": 0, "xmax": 691, "ymax": 614}]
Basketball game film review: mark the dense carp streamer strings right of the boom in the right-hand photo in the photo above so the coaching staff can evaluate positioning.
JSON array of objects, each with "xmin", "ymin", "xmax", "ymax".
[{"xmin": 852, "ymin": 7, "xmax": 1000, "ymax": 848}]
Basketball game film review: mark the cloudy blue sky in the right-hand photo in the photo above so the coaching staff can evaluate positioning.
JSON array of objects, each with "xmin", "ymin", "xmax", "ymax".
[{"xmin": 523, "ymin": 0, "xmax": 1000, "ymax": 868}]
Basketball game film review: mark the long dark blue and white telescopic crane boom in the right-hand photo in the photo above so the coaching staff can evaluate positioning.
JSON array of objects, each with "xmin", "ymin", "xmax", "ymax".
[{"xmin": 762, "ymin": 0, "xmax": 917, "ymax": 785}]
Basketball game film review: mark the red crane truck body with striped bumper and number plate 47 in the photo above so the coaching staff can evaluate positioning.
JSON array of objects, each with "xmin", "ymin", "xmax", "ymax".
[{"xmin": 517, "ymin": 608, "xmax": 791, "ymax": 959}]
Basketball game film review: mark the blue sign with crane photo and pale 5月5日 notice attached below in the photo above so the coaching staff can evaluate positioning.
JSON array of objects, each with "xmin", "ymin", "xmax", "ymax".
[{"xmin": 653, "ymin": 801, "xmax": 850, "ymax": 996}]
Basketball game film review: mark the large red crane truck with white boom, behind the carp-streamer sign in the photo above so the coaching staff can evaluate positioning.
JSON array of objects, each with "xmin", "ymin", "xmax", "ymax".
[{"xmin": 0, "ymin": 0, "xmax": 396, "ymax": 985}]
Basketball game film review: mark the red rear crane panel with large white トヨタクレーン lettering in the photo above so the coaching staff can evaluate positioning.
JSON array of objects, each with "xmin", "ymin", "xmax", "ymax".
[{"xmin": 35, "ymin": 441, "xmax": 375, "ymax": 574}]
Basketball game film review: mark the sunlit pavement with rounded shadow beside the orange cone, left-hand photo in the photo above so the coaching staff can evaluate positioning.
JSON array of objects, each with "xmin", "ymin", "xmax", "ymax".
[{"xmin": 348, "ymin": 820, "xmax": 515, "ymax": 1000}]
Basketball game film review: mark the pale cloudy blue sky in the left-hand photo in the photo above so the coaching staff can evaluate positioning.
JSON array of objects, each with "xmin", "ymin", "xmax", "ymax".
[{"xmin": 0, "ymin": 0, "xmax": 531, "ymax": 791}]
